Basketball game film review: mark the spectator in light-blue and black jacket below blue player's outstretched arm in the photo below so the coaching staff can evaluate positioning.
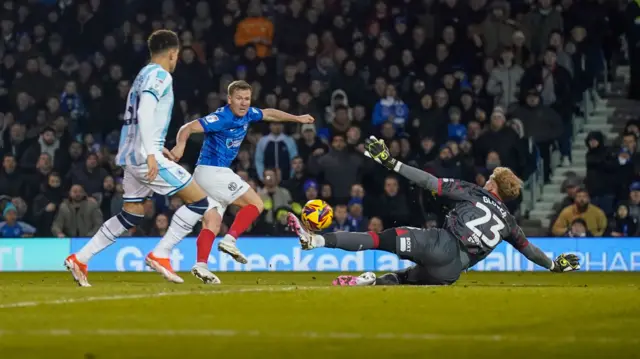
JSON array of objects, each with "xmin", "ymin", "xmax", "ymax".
[{"xmin": 255, "ymin": 122, "xmax": 298, "ymax": 181}]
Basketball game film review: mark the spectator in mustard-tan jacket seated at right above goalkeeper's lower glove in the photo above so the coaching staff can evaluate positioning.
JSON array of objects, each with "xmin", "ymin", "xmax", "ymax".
[{"xmin": 552, "ymin": 189, "xmax": 607, "ymax": 237}]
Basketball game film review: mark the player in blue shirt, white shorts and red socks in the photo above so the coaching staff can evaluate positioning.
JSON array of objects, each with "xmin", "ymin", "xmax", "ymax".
[{"xmin": 171, "ymin": 81, "xmax": 314, "ymax": 283}]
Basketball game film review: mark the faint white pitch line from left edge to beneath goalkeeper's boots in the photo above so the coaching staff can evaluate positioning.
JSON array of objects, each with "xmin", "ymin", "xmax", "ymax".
[{"xmin": 0, "ymin": 286, "xmax": 331, "ymax": 309}]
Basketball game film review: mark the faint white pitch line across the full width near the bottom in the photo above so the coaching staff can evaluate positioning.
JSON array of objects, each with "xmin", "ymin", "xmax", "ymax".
[{"xmin": 0, "ymin": 329, "xmax": 640, "ymax": 344}]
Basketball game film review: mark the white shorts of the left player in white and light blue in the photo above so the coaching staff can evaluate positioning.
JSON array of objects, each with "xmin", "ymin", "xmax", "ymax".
[{"xmin": 122, "ymin": 157, "xmax": 192, "ymax": 202}]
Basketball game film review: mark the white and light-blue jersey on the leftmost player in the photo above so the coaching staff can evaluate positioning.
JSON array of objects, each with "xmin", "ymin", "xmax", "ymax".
[{"xmin": 116, "ymin": 64, "xmax": 173, "ymax": 166}]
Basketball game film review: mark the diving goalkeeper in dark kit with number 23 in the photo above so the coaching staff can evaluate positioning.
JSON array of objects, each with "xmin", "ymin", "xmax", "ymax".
[{"xmin": 288, "ymin": 136, "xmax": 580, "ymax": 285}]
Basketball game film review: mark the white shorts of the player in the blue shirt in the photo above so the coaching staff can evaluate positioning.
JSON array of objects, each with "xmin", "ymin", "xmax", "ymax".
[{"xmin": 193, "ymin": 166, "xmax": 251, "ymax": 216}]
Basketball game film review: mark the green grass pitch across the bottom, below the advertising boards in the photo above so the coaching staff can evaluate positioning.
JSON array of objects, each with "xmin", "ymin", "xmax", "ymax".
[{"xmin": 0, "ymin": 273, "xmax": 640, "ymax": 359}]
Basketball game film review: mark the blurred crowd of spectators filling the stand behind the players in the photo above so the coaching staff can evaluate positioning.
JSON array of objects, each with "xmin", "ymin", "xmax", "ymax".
[{"xmin": 0, "ymin": 0, "xmax": 640, "ymax": 237}]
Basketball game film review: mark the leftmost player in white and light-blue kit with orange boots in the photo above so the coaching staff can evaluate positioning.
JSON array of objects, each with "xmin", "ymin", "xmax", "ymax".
[{"xmin": 64, "ymin": 30, "xmax": 220, "ymax": 287}]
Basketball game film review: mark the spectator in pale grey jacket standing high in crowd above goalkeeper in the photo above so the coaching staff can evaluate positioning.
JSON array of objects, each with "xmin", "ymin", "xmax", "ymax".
[{"xmin": 487, "ymin": 47, "xmax": 524, "ymax": 109}]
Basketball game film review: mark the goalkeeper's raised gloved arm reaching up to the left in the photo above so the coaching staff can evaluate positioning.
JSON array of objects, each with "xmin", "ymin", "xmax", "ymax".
[{"xmin": 364, "ymin": 136, "xmax": 438, "ymax": 191}]
